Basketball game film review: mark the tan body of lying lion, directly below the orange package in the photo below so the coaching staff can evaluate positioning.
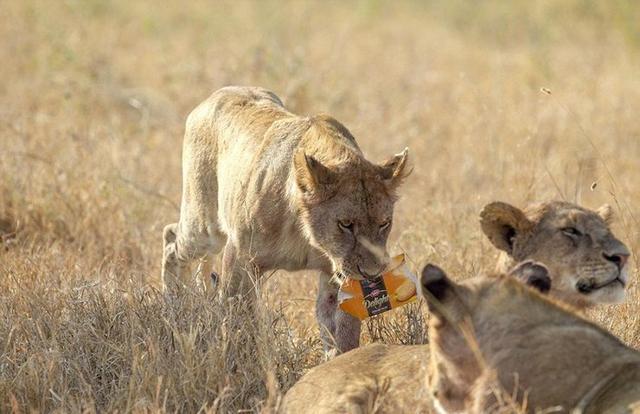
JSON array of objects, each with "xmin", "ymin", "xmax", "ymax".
[{"xmin": 279, "ymin": 344, "xmax": 432, "ymax": 414}]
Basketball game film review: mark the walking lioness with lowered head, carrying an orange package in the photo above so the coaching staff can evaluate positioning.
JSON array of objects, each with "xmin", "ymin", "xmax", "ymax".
[{"xmin": 162, "ymin": 87, "xmax": 407, "ymax": 351}]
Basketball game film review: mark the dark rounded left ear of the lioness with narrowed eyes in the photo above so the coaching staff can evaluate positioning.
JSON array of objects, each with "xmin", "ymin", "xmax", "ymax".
[{"xmin": 480, "ymin": 201, "xmax": 533, "ymax": 254}]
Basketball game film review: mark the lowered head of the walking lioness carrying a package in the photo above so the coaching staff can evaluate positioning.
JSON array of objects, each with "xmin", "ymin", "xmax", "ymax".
[{"xmin": 294, "ymin": 129, "xmax": 408, "ymax": 279}]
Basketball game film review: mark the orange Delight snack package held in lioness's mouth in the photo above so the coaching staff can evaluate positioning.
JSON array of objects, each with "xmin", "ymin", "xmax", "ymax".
[{"xmin": 338, "ymin": 254, "xmax": 417, "ymax": 320}]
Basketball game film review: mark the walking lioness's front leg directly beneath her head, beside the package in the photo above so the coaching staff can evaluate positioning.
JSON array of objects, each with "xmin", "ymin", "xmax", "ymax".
[{"xmin": 316, "ymin": 273, "xmax": 361, "ymax": 357}]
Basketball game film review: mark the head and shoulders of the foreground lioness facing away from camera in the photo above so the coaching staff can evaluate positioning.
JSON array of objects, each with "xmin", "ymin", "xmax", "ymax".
[{"xmin": 421, "ymin": 262, "xmax": 640, "ymax": 413}]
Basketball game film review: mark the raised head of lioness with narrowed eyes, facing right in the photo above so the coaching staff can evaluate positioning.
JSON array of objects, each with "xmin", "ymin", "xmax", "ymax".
[{"xmin": 480, "ymin": 201, "xmax": 629, "ymax": 308}]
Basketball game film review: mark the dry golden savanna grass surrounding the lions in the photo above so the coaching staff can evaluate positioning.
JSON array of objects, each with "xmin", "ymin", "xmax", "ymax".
[{"xmin": 0, "ymin": 0, "xmax": 640, "ymax": 412}]
